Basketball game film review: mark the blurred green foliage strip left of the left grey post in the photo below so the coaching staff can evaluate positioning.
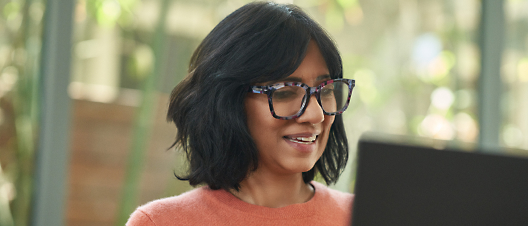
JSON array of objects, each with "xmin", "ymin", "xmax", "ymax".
[{"xmin": 0, "ymin": 0, "xmax": 44, "ymax": 225}]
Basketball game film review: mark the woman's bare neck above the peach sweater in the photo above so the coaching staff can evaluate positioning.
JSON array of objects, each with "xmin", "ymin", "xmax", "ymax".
[{"xmin": 231, "ymin": 170, "xmax": 314, "ymax": 208}]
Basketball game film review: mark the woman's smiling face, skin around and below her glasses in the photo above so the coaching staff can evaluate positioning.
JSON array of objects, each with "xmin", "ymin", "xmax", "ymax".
[{"xmin": 245, "ymin": 41, "xmax": 335, "ymax": 174}]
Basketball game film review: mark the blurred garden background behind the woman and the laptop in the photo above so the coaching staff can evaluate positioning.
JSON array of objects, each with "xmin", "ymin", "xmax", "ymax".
[{"xmin": 0, "ymin": 0, "xmax": 528, "ymax": 226}]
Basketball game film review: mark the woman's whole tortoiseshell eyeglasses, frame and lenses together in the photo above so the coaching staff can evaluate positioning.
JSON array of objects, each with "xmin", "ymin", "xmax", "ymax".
[{"xmin": 248, "ymin": 79, "xmax": 356, "ymax": 120}]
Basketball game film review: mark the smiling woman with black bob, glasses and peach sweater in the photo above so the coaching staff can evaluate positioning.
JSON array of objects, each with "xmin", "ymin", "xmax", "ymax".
[{"xmin": 127, "ymin": 2, "xmax": 354, "ymax": 225}]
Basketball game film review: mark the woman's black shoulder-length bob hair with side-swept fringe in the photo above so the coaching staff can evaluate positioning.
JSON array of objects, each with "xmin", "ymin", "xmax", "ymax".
[{"xmin": 167, "ymin": 2, "xmax": 348, "ymax": 190}]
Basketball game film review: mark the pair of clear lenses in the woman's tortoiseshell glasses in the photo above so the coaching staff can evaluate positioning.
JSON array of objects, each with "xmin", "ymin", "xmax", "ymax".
[{"xmin": 271, "ymin": 82, "xmax": 348, "ymax": 117}]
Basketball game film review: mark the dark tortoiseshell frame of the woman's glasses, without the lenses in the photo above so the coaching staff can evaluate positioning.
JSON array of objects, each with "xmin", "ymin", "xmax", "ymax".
[{"xmin": 248, "ymin": 78, "xmax": 356, "ymax": 120}]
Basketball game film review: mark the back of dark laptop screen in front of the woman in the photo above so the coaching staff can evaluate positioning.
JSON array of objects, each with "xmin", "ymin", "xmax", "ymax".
[{"xmin": 352, "ymin": 134, "xmax": 528, "ymax": 226}]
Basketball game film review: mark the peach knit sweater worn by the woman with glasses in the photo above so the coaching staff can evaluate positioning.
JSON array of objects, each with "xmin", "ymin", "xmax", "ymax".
[{"xmin": 126, "ymin": 181, "xmax": 354, "ymax": 226}]
